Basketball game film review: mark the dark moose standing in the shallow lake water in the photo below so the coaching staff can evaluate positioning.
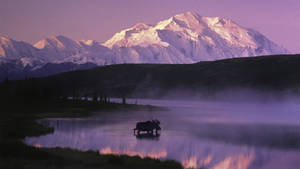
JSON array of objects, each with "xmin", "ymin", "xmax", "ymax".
[{"xmin": 133, "ymin": 120, "xmax": 161, "ymax": 135}]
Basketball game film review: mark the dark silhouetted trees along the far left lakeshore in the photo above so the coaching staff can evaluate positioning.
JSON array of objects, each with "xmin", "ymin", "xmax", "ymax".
[{"xmin": 0, "ymin": 78, "xmax": 126, "ymax": 104}]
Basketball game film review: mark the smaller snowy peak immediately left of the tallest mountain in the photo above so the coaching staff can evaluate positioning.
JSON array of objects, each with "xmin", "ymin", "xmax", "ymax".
[{"xmin": 34, "ymin": 36, "xmax": 112, "ymax": 65}]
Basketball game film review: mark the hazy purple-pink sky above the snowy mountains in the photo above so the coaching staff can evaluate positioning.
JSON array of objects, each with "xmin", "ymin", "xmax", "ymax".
[{"xmin": 0, "ymin": 0, "xmax": 300, "ymax": 53}]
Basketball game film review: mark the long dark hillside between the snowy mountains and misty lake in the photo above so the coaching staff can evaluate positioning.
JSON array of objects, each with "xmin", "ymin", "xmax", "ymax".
[{"xmin": 0, "ymin": 55, "xmax": 300, "ymax": 102}]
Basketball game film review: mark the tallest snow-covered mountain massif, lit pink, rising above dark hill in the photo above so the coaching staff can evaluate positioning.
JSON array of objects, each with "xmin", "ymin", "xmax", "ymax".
[{"xmin": 103, "ymin": 12, "xmax": 289, "ymax": 63}]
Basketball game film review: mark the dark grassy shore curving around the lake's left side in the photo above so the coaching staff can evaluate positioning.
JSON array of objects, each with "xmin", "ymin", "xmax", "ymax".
[{"xmin": 0, "ymin": 100, "xmax": 182, "ymax": 169}]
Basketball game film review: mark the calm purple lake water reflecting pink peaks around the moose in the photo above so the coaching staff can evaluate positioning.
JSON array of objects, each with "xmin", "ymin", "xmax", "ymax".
[{"xmin": 25, "ymin": 99, "xmax": 300, "ymax": 169}]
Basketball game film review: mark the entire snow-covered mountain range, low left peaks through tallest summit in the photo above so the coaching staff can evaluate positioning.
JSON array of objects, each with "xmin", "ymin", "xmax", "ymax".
[{"xmin": 0, "ymin": 12, "xmax": 290, "ymax": 80}]
